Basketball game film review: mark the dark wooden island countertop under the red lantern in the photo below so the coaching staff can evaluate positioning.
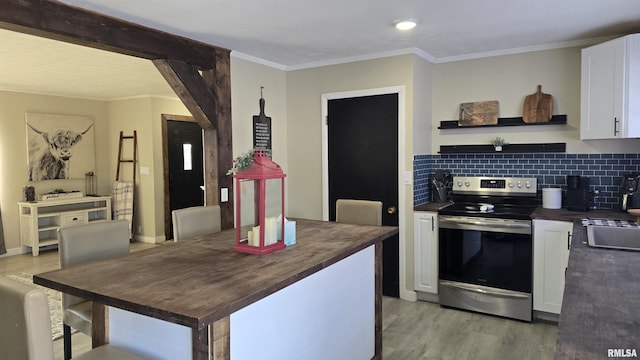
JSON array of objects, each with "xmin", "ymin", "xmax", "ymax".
[{"xmin": 33, "ymin": 219, "xmax": 398, "ymax": 329}]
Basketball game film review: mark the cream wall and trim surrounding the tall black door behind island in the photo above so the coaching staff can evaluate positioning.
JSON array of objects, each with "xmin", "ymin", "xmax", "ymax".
[{"xmin": 286, "ymin": 55, "xmax": 420, "ymax": 297}]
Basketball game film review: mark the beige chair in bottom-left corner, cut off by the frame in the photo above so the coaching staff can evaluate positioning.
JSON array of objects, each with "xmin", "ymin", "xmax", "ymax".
[{"xmin": 0, "ymin": 276, "xmax": 146, "ymax": 360}]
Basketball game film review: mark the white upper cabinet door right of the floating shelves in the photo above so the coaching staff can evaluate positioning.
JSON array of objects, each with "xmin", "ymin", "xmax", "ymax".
[{"xmin": 580, "ymin": 38, "xmax": 625, "ymax": 140}]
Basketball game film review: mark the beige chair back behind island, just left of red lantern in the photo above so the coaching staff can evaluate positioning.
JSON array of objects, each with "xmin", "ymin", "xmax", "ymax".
[{"xmin": 171, "ymin": 205, "xmax": 222, "ymax": 241}]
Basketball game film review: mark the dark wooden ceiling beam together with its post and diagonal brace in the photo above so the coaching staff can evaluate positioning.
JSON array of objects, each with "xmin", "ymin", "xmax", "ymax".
[{"xmin": 0, "ymin": 0, "xmax": 233, "ymax": 229}]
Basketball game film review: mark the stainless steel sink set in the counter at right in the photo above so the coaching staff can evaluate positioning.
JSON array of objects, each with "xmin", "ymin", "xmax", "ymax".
[{"xmin": 587, "ymin": 225, "xmax": 640, "ymax": 251}]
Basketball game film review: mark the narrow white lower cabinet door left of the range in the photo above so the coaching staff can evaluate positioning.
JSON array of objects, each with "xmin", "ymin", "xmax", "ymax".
[{"xmin": 413, "ymin": 212, "xmax": 438, "ymax": 294}]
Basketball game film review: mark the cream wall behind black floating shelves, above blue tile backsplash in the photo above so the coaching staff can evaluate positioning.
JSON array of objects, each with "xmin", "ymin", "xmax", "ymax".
[{"xmin": 431, "ymin": 47, "xmax": 640, "ymax": 154}]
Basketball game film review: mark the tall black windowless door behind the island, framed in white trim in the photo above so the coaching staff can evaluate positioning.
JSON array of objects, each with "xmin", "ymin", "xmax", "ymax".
[{"xmin": 328, "ymin": 94, "xmax": 400, "ymax": 297}]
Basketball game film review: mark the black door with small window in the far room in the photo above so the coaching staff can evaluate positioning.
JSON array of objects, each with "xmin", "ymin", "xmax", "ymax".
[{"xmin": 167, "ymin": 120, "xmax": 204, "ymax": 238}]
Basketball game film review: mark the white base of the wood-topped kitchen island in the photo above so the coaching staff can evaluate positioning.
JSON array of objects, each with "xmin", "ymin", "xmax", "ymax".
[{"xmin": 109, "ymin": 245, "xmax": 375, "ymax": 360}]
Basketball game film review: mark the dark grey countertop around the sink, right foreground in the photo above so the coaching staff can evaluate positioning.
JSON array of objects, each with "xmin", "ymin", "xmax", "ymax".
[{"xmin": 555, "ymin": 218, "xmax": 640, "ymax": 360}]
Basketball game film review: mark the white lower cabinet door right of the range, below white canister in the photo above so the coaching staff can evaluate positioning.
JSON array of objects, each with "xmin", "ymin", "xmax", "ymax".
[{"xmin": 533, "ymin": 220, "xmax": 573, "ymax": 314}]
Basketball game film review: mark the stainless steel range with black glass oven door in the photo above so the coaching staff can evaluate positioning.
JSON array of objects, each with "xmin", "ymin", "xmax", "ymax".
[{"xmin": 438, "ymin": 177, "xmax": 537, "ymax": 321}]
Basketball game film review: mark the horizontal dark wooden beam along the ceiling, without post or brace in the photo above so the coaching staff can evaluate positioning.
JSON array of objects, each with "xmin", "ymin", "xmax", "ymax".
[{"xmin": 0, "ymin": 0, "xmax": 228, "ymax": 70}]
